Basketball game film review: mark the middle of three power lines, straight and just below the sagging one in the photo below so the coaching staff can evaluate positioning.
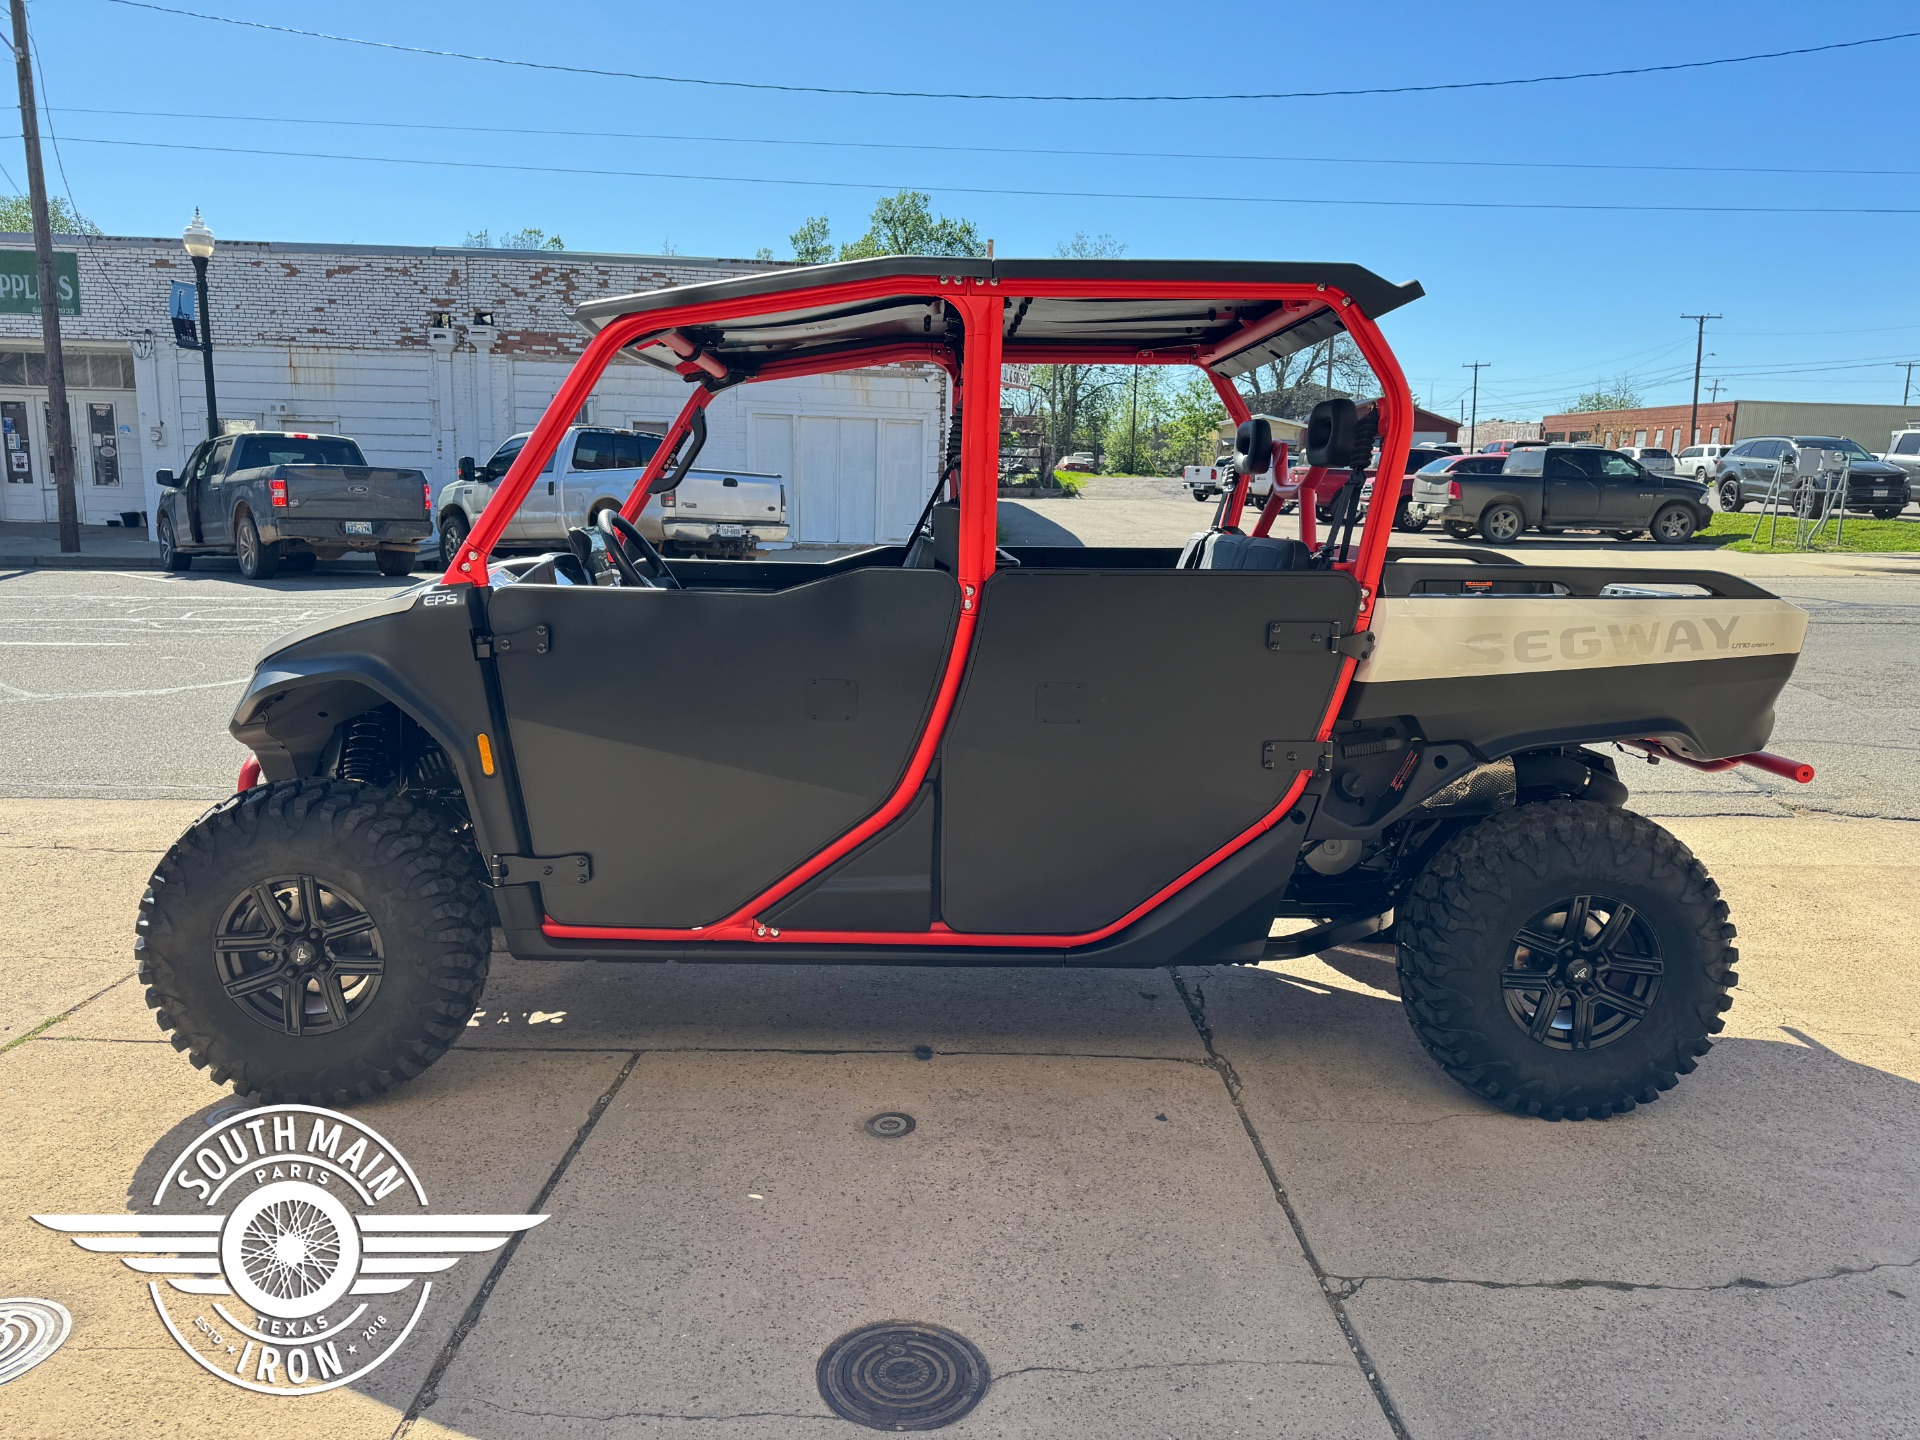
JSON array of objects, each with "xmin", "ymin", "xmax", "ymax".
[{"xmin": 37, "ymin": 106, "xmax": 1920, "ymax": 183}]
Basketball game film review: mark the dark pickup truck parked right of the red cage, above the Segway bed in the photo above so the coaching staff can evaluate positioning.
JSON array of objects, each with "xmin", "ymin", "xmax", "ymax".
[{"xmin": 1411, "ymin": 445, "xmax": 1713, "ymax": 545}]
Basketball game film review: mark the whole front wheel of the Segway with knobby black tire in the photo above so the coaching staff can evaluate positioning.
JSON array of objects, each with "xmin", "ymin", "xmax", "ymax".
[{"xmin": 134, "ymin": 780, "xmax": 493, "ymax": 1106}]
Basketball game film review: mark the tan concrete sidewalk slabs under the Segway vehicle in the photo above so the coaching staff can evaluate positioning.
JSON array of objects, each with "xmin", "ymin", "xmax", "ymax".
[{"xmin": 0, "ymin": 801, "xmax": 1920, "ymax": 1440}]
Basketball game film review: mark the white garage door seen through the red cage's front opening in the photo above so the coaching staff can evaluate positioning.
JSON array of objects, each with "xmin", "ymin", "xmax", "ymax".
[{"xmin": 753, "ymin": 415, "xmax": 933, "ymax": 545}]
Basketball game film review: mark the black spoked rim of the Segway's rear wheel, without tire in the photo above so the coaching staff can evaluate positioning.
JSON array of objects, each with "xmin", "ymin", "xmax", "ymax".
[{"xmin": 1500, "ymin": 895, "xmax": 1667, "ymax": 1050}]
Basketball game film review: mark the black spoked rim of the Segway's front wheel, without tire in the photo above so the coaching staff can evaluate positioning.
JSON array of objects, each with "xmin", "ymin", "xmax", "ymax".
[{"xmin": 213, "ymin": 876, "xmax": 386, "ymax": 1035}]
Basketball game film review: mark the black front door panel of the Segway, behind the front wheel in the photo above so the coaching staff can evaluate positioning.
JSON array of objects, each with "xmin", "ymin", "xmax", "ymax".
[{"xmin": 490, "ymin": 568, "xmax": 958, "ymax": 929}]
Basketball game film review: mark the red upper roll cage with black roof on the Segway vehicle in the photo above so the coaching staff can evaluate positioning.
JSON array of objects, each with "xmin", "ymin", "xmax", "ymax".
[{"xmin": 444, "ymin": 257, "xmax": 1419, "ymax": 622}]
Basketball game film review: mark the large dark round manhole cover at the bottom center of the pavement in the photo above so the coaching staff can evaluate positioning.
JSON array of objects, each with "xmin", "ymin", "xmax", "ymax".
[{"xmin": 818, "ymin": 1321, "xmax": 993, "ymax": 1430}]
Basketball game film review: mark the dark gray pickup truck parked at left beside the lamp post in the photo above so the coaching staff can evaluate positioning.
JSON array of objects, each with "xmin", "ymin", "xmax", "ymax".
[{"xmin": 154, "ymin": 430, "xmax": 434, "ymax": 580}]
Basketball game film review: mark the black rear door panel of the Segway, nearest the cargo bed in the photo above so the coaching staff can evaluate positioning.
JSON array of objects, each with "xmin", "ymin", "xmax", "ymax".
[{"xmin": 939, "ymin": 570, "xmax": 1359, "ymax": 935}]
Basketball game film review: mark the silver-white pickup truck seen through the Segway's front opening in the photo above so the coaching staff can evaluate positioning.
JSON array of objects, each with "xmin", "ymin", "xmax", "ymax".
[{"xmin": 434, "ymin": 424, "xmax": 787, "ymax": 564}]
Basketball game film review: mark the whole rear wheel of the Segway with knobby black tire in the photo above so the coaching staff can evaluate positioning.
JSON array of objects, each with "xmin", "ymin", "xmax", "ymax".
[{"xmin": 1398, "ymin": 799, "xmax": 1740, "ymax": 1119}]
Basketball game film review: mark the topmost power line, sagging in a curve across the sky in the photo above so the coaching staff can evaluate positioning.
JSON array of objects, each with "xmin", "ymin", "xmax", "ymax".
[{"xmin": 108, "ymin": 0, "xmax": 1920, "ymax": 104}]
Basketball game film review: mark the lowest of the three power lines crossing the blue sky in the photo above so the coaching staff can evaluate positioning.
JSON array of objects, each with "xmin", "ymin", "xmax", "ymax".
[{"xmin": 30, "ymin": 132, "xmax": 1920, "ymax": 215}]
